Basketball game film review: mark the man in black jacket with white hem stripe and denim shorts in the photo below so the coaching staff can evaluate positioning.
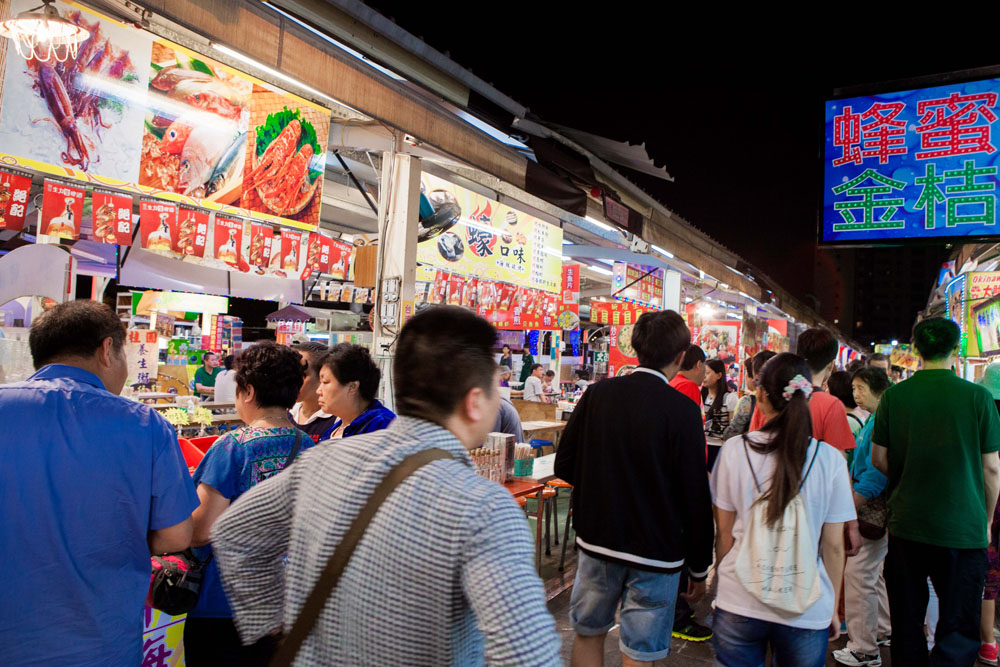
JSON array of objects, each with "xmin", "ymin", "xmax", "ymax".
[{"xmin": 555, "ymin": 311, "xmax": 714, "ymax": 665}]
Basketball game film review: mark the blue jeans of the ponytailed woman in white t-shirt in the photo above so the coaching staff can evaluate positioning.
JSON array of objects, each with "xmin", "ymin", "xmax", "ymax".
[{"xmin": 712, "ymin": 608, "xmax": 829, "ymax": 667}]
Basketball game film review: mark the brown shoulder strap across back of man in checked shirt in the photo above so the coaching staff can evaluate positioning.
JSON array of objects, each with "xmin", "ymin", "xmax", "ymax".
[{"xmin": 271, "ymin": 449, "xmax": 454, "ymax": 667}]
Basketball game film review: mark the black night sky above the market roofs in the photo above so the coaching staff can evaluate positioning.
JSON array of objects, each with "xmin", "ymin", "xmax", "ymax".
[{"xmin": 368, "ymin": 1, "xmax": 998, "ymax": 340}]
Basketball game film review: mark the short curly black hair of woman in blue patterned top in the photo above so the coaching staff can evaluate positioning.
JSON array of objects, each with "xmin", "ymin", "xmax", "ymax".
[{"xmin": 236, "ymin": 340, "xmax": 306, "ymax": 410}]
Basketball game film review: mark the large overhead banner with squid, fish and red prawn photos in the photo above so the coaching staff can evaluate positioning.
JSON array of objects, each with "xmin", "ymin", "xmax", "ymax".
[{"xmin": 0, "ymin": 0, "xmax": 330, "ymax": 231}]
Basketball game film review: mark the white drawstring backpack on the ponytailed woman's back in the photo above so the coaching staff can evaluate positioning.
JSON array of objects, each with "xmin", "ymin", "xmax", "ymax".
[{"xmin": 735, "ymin": 439, "xmax": 822, "ymax": 617}]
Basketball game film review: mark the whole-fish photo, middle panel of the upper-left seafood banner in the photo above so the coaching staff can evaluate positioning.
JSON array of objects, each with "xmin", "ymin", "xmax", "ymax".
[{"xmin": 138, "ymin": 40, "xmax": 253, "ymax": 204}]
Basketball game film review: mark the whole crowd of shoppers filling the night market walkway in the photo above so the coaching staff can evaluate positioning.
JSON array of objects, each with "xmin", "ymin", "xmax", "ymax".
[{"xmin": 0, "ymin": 301, "xmax": 1000, "ymax": 667}]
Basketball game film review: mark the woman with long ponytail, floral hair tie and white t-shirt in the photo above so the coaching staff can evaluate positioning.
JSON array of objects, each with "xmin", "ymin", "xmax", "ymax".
[{"xmin": 711, "ymin": 353, "xmax": 856, "ymax": 667}]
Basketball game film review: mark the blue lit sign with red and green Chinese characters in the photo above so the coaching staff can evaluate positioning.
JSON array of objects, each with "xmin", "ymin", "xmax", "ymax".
[{"xmin": 820, "ymin": 78, "xmax": 1000, "ymax": 244}]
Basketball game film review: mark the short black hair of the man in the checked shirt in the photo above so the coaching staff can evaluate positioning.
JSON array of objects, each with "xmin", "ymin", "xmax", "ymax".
[{"xmin": 392, "ymin": 306, "xmax": 497, "ymax": 424}]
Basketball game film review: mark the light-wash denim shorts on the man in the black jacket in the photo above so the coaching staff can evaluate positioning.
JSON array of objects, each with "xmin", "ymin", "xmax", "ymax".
[{"xmin": 569, "ymin": 551, "xmax": 680, "ymax": 662}]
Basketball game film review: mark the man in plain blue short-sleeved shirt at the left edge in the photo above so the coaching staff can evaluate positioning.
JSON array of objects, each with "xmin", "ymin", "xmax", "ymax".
[{"xmin": 0, "ymin": 301, "xmax": 198, "ymax": 665}]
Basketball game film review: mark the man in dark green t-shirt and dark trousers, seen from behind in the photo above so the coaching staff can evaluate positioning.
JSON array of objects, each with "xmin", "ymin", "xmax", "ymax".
[{"xmin": 872, "ymin": 318, "xmax": 1000, "ymax": 665}]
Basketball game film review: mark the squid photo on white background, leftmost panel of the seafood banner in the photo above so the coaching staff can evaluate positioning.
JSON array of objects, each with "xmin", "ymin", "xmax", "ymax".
[{"xmin": 0, "ymin": 0, "xmax": 152, "ymax": 183}]
